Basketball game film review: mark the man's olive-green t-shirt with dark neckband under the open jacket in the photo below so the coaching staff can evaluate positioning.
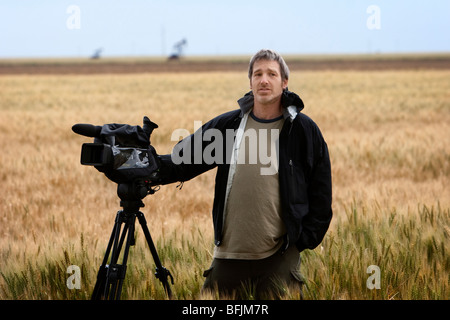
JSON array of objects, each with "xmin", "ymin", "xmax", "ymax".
[{"xmin": 214, "ymin": 114, "xmax": 286, "ymax": 260}]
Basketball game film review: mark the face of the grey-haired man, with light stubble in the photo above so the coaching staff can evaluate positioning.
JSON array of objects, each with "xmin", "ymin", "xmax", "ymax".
[{"xmin": 250, "ymin": 60, "xmax": 288, "ymax": 105}]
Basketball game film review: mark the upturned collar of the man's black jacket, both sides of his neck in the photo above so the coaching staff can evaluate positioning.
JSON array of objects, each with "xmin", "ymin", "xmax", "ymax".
[{"xmin": 238, "ymin": 88, "xmax": 305, "ymax": 122}]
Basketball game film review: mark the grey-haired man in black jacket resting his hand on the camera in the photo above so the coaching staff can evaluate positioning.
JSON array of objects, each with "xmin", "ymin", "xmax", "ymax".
[{"xmin": 156, "ymin": 50, "xmax": 332, "ymax": 298}]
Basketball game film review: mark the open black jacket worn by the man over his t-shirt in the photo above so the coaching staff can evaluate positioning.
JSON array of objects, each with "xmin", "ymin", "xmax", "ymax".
[{"xmin": 160, "ymin": 90, "xmax": 332, "ymax": 251}]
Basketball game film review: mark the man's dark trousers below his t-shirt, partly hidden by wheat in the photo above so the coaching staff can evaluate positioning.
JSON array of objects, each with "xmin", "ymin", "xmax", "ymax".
[{"xmin": 203, "ymin": 247, "xmax": 303, "ymax": 299}]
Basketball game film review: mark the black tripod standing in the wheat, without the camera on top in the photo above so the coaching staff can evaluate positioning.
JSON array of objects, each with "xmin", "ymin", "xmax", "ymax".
[{"xmin": 91, "ymin": 182, "xmax": 173, "ymax": 300}]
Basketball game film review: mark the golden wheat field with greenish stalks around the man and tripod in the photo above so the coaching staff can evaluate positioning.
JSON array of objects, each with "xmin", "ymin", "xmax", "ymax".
[{"xmin": 0, "ymin": 66, "xmax": 450, "ymax": 300}]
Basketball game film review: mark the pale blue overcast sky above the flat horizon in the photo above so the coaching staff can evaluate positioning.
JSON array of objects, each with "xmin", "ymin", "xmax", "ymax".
[{"xmin": 0, "ymin": 0, "xmax": 450, "ymax": 58}]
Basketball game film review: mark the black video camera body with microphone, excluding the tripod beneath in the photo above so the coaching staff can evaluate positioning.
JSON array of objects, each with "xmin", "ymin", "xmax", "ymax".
[{"xmin": 72, "ymin": 116, "xmax": 159, "ymax": 192}]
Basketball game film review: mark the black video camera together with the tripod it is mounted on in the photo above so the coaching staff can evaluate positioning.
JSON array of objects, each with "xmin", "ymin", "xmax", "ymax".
[{"xmin": 72, "ymin": 116, "xmax": 173, "ymax": 299}]
